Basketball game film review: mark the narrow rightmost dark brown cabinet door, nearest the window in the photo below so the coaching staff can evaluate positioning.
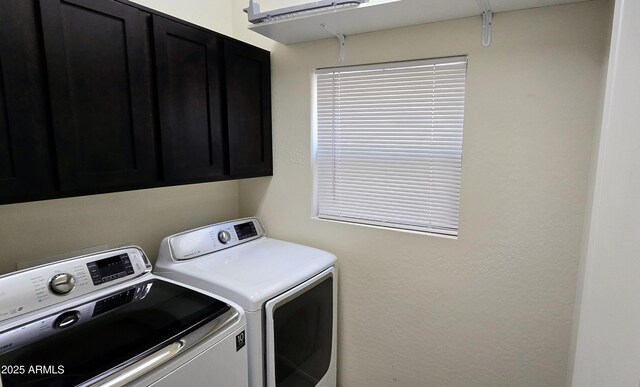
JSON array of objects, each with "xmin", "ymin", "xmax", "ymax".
[{"xmin": 224, "ymin": 40, "xmax": 272, "ymax": 177}]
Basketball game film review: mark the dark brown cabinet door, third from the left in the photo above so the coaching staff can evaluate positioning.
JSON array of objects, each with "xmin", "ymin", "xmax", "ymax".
[{"xmin": 153, "ymin": 15, "xmax": 226, "ymax": 182}]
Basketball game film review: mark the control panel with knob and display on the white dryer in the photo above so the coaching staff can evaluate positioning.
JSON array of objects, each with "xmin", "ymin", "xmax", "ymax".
[{"xmin": 168, "ymin": 218, "xmax": 265, "ymax": 261}]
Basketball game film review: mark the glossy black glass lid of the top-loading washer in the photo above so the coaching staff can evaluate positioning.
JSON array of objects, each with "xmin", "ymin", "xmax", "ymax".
[{"xmin": 0, "ymin": 279, "xmax": 236, "ymax": 387}]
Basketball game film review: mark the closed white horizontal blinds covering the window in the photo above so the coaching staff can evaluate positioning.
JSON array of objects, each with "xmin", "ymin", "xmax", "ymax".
[{"xmin": 314, "ymin": 57, "xmax": 467, "ymax": 235}]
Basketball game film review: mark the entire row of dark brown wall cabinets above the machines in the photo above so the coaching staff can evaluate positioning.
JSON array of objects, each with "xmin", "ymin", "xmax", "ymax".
[{"xmin": 0, "ymin": 0, "xmax": 272, "ymax": 204}]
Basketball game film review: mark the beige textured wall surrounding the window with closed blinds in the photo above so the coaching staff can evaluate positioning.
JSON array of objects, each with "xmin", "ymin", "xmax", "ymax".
[{"xmin": 239, "ymin": 1, "xmax": 610, "ymax": 387}]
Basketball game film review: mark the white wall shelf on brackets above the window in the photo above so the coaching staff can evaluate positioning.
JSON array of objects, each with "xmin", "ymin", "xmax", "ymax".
[{"xmin": 247, "ymin": 0, "xmax": 588, "ymax": 44}]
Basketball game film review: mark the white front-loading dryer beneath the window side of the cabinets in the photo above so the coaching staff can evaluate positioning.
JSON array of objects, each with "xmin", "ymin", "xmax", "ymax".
[{"xmin": 154, "ymin": 218, "xmax": 338, "ymax": 387}]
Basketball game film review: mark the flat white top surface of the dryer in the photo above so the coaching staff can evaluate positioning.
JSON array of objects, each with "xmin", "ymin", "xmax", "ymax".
[{"xmin": 154, "ymin": 238, "xmax": 336, "ymax": 311}]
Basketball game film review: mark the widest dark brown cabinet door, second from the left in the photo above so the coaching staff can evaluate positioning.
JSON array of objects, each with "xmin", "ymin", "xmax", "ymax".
[{"xmin": 40, "ymin": 0, "xmax": 156, "ymax": 193}]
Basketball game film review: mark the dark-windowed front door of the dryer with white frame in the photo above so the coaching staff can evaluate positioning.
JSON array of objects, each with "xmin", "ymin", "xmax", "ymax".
[{"xmin": 265, "ymin": 267, "xmax": 337, "ymax": 387}]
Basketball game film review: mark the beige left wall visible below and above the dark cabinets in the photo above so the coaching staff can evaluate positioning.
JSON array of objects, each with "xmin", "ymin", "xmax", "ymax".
[{"xmin": 0, "ymin": 0, "xmax": 238, "ymax": 274}]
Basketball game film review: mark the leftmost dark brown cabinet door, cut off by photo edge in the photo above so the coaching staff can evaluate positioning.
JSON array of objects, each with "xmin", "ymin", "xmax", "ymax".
[{"xmin": 0, "ymin": 0, "xmax": 55, "ymax": 203}]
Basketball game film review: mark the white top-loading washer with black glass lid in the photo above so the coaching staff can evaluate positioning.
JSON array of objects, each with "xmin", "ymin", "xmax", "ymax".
[{"xmin": 0, "ymin": 247, "xmax": 248, "ymax": 387}]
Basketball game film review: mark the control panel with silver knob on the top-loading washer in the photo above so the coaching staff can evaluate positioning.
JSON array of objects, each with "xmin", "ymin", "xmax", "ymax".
[{"xmin": 0, "ymin": 246, "xmax": 151, "ymax": 324}]
